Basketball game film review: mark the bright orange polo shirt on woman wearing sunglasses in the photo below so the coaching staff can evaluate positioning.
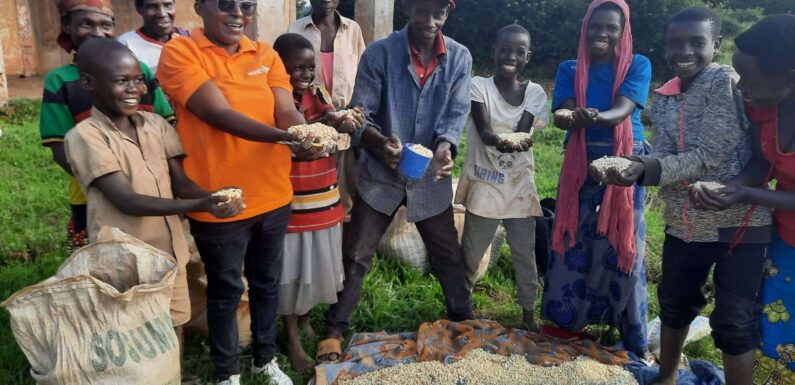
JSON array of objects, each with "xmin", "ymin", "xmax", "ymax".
[{"xmin": 157, "ymin": 28, "xmax": 293, "ymax": 222}]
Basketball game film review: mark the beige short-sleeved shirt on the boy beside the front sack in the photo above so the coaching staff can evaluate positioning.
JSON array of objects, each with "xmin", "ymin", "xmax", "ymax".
[{"xmin": 65, "ymin": 108, "xmax": 190, "ymax": 266}]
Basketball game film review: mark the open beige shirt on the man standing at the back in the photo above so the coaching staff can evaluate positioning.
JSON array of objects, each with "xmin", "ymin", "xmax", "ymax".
[{"xmin": 287, "ymin": 13, "xmax": 365, "ymax": 109}]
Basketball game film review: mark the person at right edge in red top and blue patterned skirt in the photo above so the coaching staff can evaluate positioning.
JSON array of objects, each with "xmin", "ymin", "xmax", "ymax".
[{"xmin": 691, "ymin": 15, "xmax": 795, "ymax": 385}]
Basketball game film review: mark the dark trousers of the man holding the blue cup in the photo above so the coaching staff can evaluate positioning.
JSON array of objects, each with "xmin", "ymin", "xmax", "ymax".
[{"xmin": 326, "ymin": 196, "xmax": 472, "ymax": 336}]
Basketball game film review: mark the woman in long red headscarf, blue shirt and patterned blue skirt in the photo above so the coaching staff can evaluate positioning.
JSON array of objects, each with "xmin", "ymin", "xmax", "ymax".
[{"xmin": 542, "ymin": 0, "xmax": 651, "ymax": 356}]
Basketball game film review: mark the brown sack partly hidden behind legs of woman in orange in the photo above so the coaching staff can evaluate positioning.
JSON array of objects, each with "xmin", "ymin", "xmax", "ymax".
[{"xmin": 182, "ymin": 220, "xmax": 251, "ymax": 348}]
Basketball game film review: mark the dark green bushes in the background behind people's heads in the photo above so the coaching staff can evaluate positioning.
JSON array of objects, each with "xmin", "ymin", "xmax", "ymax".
[{"xmin": 332, "ymin": 0, "xmax": 776, "ymax": 79}]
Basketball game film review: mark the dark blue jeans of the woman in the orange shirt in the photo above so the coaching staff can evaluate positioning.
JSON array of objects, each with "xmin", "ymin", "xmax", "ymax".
[{"xmin": 190, "ymin": 205, "xmax": 290, "ymax": 380}]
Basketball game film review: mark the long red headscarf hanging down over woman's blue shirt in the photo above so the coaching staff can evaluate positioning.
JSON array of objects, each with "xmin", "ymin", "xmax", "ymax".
[{"xmin": 552, "ymin": 0, "xmax": 635, "ymax": 274}]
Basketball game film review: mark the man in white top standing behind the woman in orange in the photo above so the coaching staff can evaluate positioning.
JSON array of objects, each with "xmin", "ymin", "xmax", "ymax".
[{"xmin": 118, "ymin": 0, "xmax": 190, "ymax": 73}]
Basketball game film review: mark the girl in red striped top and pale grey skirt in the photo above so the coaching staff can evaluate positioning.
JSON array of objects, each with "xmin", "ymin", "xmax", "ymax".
[{"xmin": 273, "ymin": 33, "xmax": 364, "ymax": 371}]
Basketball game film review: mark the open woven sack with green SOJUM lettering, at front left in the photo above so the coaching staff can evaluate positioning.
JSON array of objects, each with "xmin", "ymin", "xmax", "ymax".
[{"xmin": 0, "ymin": 227, "xmax": 180, "ymax": 385}]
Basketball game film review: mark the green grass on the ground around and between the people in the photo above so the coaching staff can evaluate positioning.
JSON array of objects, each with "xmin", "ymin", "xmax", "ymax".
[{"xmin": 0, "ymin": 101, "xmax": 720, "ymax": 385}]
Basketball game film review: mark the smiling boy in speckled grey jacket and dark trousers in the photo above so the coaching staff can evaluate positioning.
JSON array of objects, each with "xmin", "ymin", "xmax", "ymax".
[{"xmin": 605, "ymin": 8, "xmax": 770, "ymax": 385}]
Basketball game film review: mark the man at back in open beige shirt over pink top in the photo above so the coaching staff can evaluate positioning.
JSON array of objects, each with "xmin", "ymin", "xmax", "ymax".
[{"xmin": 287, "ymin": 0, "xmax": 365, "ymax": 216}]
